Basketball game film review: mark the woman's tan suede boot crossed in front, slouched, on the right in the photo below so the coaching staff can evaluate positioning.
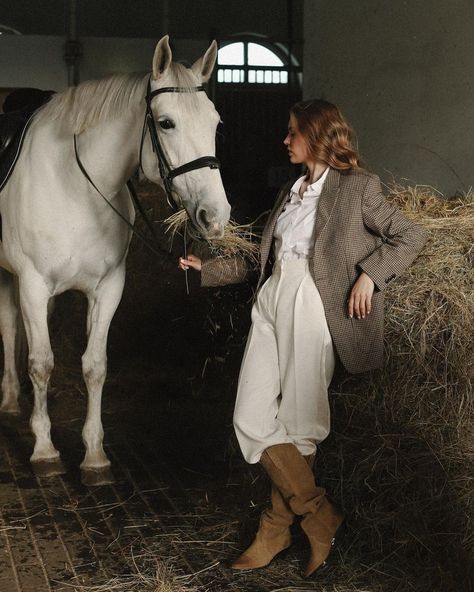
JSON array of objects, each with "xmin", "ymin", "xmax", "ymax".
[{"xmin": 260, "ymin": 444, "xmax": 344, "ymax": 577}]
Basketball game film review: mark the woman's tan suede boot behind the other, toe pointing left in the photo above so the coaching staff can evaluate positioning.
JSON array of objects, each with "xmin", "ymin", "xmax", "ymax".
[{"xmin": 231, "ymin": 454, "xmax": 315, "ymax": 569}]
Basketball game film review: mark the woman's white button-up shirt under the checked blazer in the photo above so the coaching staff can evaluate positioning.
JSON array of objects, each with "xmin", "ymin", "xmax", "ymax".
[{"xmin": 273, "ymin": 167, "xmax": 329, "ymax": 260}]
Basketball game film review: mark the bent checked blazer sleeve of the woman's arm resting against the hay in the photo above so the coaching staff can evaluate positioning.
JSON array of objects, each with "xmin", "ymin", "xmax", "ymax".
[{"xmin": 358, "ymin": 175, "xmax": 428, "ymax": 290}]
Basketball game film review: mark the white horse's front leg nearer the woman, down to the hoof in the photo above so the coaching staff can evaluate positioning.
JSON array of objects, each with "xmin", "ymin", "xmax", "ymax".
[{"xmin": 81, "ymin": 266, "xmax": 125, "ymax": 485}]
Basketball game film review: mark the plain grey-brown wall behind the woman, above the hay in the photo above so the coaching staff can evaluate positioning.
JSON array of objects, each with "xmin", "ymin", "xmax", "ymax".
[{"xmin": 304, "ymin": 0, "xmax": 474, "ymax": 195}]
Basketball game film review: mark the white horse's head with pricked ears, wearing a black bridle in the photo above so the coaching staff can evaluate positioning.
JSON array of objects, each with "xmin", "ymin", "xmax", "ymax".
[{"xmin": 142, "ymin": 36, "xmax": 230, "ymax": 238}]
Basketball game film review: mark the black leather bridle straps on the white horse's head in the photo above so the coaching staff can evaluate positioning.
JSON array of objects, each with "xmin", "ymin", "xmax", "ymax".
[{"xmin": 140, "ymin": 75, "xmax": 220, "ymax": 211}]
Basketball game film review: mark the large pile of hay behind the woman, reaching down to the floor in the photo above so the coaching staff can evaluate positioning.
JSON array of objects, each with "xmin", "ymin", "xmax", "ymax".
[{"xmin": 316, "ymin": 186, "xmax": 474, "ymax": 592}]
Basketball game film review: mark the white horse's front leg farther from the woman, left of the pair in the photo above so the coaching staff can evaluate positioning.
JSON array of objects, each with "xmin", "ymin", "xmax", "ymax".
[{"xmin": 20, "ymin": 275, "xmax": 64, "ymax": 477}]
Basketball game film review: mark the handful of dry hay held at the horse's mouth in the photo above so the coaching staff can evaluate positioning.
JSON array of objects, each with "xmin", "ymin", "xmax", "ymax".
[{"xmin": 164, "ymin": 209, "xmax": 260, "ymax": 265}]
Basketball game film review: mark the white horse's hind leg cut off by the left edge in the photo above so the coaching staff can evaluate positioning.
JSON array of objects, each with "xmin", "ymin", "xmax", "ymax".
[{"xmin": 0, "ymin": 269, "xmax": 20, "ymax": 415}]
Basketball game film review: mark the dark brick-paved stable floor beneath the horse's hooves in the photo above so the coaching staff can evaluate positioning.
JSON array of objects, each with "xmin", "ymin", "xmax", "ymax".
[{"xmin": 0, "ymin": 384, "xmax": 314, "ymax": 592}]
